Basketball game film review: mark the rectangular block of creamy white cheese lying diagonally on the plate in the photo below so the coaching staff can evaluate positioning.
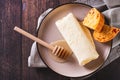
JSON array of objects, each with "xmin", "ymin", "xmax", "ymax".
[{"xmin": 56, "ymin": 13, "xmax": 99, "ymax": 65}]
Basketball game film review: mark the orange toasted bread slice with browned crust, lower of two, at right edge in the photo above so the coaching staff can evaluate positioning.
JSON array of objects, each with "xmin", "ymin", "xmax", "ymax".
[{"xmin": 93, "ymin": 25, "xmax": 120, "ymax": 42}]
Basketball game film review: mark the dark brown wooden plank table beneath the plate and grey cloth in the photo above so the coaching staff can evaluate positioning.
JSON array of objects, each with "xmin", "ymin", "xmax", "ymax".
[{"xmin": 0, "ymin": 0, "xmax": 120, "ymax": 80}]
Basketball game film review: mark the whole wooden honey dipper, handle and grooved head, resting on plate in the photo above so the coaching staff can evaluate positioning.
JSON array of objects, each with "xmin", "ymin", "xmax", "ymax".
[{"xmin": 14, "ymin": 26, "xmax": 69, "ymax": 59}]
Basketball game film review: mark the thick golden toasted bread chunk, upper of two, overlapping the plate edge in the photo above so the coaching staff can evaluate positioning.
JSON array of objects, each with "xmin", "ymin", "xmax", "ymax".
[{"xmin": 83, "ymin": 8, "xmax": 105, "ymax": 32}]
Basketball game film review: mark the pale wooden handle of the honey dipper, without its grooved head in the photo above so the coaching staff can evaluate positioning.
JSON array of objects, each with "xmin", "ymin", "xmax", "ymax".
[{"xmin": 14, "ymin": 26, "xmax": 54, "ymax": 50}]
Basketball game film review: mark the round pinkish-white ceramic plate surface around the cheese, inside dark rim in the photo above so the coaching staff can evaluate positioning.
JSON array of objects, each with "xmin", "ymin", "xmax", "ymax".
[{"xmin": 38, "ymin": 4, "xmax": 111, "ymax": 77}]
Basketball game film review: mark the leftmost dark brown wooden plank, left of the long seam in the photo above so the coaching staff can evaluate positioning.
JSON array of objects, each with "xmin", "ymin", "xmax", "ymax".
[{"xmin": 0, "ymin": 0, "xmax": 22, "ymax": 80}]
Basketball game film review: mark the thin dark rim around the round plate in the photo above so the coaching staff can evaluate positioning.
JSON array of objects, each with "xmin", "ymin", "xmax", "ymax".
[{"xmin": 36, "ymin": 2, "xmax": 113, "ymax": 78}]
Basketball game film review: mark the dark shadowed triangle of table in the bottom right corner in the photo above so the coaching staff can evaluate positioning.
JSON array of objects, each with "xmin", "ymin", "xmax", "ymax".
[{"xmin": 85, "ymin": 57, "xmax": 120, "ymax": 80}]
